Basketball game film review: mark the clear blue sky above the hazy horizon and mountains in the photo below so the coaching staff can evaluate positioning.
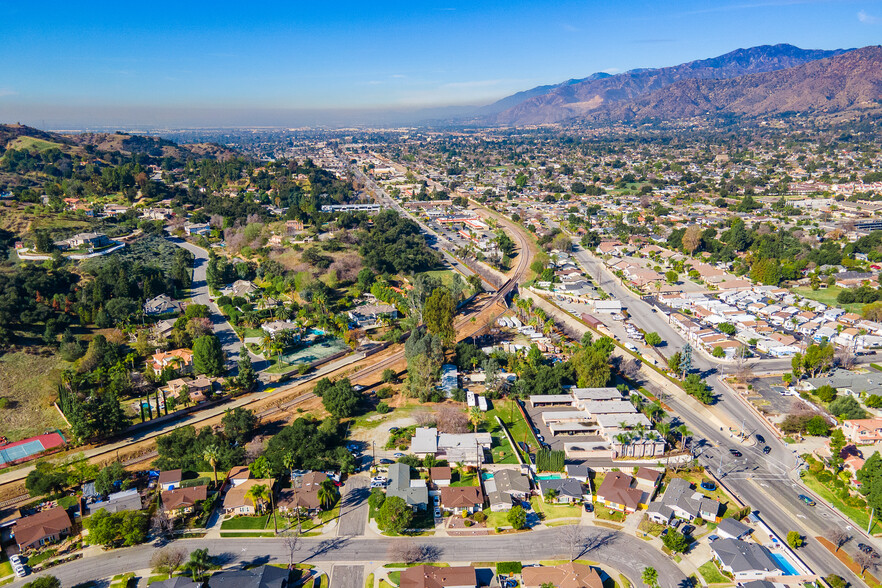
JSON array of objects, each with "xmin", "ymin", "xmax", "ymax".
[{"xmin": 0, "ymin": 0, "xmax": 882, "ymax": 123}]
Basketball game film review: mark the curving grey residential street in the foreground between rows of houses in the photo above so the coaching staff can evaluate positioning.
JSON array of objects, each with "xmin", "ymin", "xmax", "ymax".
[{"xmin": 10, "ymin": 527, "xmax": 690, "ymax": 588}]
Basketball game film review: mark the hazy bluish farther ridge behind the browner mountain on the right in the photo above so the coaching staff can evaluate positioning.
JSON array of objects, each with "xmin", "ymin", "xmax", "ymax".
[{"xmin": 495, "ymin": 45, "xmax": 846, "ymax": 125}]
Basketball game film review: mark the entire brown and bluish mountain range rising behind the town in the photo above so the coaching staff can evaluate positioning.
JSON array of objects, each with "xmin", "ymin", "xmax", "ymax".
[{"xmin": 478, "ymin": 44, "xmax": 882, "ymax": 126}]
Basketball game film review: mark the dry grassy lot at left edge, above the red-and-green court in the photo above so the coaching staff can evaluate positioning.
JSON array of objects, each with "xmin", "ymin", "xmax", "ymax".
[{"xmin": 0, "ymin": 352, "xmax": 66, "ymax": 441}]
